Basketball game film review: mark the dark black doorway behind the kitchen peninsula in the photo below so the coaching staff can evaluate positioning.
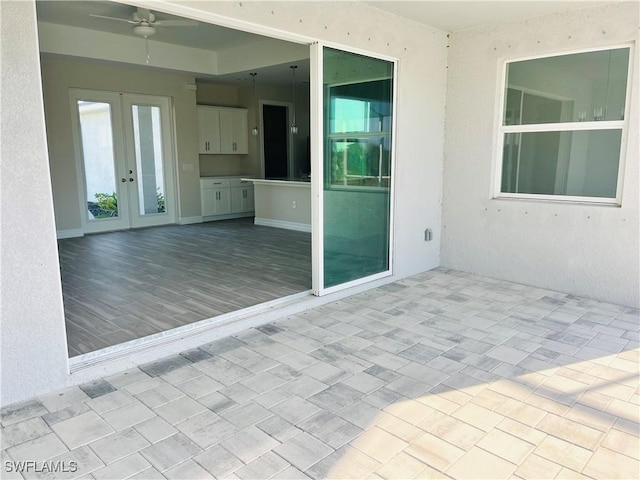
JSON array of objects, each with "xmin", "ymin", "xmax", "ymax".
[{"xmin": 262, "ymin": 105, "xmax": 289, "ymax": 179}]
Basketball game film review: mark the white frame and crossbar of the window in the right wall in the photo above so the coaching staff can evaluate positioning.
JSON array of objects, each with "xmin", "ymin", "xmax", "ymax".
[{"xmin": 492, "ymin": 42, "xmax": 635, "ymax": 206}]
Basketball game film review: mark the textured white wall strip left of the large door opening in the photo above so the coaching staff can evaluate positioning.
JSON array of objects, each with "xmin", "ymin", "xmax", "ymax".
[{"xmin": 0, "ymin": 2, "xmax": 67, "ymax": 405}]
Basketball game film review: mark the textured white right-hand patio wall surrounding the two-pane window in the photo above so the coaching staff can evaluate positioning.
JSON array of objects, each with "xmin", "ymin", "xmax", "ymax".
[{"xmin": 442, "ymin": 2, "xmax": 640, "ymax": 307}]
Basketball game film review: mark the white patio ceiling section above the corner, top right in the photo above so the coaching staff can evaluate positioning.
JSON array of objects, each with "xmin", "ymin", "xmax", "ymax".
[{"xmin": 367, "ymin": 0, "xmax": 616, "ymax": 31}]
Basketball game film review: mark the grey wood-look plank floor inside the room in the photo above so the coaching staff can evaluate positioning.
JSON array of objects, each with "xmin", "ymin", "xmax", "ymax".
[{"xmin": 58, "ymin": 218, "xmax": 311, "ymax": 357}]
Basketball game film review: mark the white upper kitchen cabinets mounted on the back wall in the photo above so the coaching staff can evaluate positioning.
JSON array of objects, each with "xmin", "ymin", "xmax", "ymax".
[{"xmin": 198, "ymin": 105, "xmax": 249, "ymax": 154}]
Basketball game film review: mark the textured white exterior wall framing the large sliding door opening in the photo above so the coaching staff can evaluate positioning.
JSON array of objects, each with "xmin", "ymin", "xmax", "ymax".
[{"xmin": 0, "ymin": 2, "xmax": 447, "ymax": 405}]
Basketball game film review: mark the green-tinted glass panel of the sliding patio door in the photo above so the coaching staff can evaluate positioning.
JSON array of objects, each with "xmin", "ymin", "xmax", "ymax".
[{"xmin": 323, "ymin": 48, "xmax": 393, "ymax": 288}]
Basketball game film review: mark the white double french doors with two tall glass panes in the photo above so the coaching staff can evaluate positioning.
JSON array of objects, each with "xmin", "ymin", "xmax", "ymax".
[{"xmin": 70, "ymin": 89, "xmax": 175, "ymax": 233}]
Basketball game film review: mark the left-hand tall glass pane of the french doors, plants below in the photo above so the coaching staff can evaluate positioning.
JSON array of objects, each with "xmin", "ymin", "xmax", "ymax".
[{"xmin": 78, "ymin": 101, "xmax": 118, "ymax": 220}]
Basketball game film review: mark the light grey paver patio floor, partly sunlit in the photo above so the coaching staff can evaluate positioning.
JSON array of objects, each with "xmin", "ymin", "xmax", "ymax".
[{"xmin": 1, "ymin": 269, "xmax": 640, "ymax": 479}]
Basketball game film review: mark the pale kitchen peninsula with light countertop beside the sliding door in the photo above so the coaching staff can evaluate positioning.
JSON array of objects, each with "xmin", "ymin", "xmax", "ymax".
[{"xmin": 243, "ymin": 178, "xmax": 311, "ymax": 232}]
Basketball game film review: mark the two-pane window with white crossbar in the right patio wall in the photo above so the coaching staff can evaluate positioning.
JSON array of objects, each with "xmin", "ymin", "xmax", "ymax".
[{"xmin": 496, "ymin": 46, "xmax": 630, "ymax": 204}]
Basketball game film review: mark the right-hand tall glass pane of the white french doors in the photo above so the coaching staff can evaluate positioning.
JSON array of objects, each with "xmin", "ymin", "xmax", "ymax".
[{"xmin": 131, "ymin": 105, "xmax": 166, "ymax": 215}]
